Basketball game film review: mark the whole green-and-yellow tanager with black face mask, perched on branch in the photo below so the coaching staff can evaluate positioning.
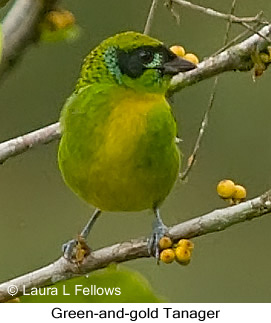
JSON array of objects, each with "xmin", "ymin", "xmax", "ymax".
[{"xmin": 58, "ymin": 31, "xmax": 196, "ymax": 259}]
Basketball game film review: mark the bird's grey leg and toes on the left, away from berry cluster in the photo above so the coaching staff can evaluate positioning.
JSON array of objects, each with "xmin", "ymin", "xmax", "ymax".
[{"xmin": 62, "ymin": 209, "xmax": 102, "ymax": 259}]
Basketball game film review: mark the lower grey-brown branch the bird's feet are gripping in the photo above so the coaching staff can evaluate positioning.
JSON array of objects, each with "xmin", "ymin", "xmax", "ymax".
[{"xmin": 0, "ymin": 190, "xmax": 271, "ymax": 302}]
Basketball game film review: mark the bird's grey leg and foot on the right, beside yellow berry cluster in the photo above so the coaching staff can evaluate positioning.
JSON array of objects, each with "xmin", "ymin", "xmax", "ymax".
[{"xmin": 148, "ymin": 208, "xmax": 168, "ymax": 261}]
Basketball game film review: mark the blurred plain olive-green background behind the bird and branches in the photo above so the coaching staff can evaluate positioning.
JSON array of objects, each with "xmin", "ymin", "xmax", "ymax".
[{"xmin": 0, "ymin": 0, "xmax": 271, "ymax": 302}]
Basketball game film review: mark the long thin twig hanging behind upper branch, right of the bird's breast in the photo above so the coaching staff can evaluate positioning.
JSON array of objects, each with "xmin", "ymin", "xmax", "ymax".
[{"xmin": 180, "ymin": 0, "xmax": 236, "ymax": 180}]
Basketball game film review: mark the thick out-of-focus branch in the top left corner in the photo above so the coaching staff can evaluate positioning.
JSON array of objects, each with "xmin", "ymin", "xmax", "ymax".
[{"xmin": 0, "ymin": 0, "xmax": 57, "ymax": 79}]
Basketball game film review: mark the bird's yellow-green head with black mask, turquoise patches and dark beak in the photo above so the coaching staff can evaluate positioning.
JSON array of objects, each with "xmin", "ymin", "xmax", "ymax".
[{"xmin": 78, "ymin": 31, "xmax": 196, "ymax": 93}]
